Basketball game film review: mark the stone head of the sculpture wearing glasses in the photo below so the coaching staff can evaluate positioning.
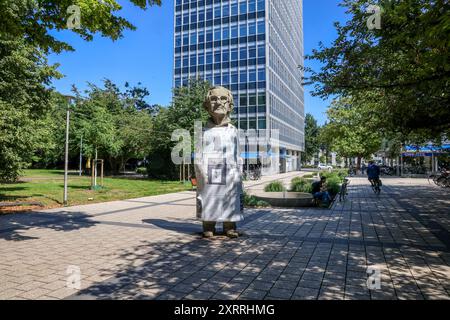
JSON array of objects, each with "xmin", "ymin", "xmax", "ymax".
[{"xmin": 203, "ymin": 87, "xmax": 234, "ymax": 126}]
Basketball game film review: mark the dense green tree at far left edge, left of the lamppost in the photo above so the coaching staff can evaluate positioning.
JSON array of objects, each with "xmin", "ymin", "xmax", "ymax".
[{"xmin": 0, "ymin": 39, "xmax": 60, "ymax": 181}]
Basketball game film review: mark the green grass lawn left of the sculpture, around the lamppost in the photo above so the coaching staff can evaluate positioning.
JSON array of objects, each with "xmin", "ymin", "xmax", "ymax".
[{"xmin": 0, "ymin": 170, "xmax": 191, "ymax": 212}]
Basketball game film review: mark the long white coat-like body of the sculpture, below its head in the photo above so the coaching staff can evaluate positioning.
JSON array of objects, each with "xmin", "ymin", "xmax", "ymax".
[{"xmin": 195, "ymin": 124, "xmax": 244, "ymax": 222}]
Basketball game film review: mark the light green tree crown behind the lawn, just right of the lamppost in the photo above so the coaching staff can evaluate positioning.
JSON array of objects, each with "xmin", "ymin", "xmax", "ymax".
[{"xmin": 71, "ymin": 79, "xmax": 153, "ymax": 174}]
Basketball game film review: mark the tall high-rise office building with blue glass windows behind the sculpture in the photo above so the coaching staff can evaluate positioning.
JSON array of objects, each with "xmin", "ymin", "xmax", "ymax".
[{"xmin": 174, "ymin": 0, "xmax": 304, "ymax": 172}]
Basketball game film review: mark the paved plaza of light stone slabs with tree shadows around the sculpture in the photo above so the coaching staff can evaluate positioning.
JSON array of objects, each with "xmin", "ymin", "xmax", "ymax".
[{"xmin": 0, "ymin": 173, "xmax": 450, "ymax": 300}]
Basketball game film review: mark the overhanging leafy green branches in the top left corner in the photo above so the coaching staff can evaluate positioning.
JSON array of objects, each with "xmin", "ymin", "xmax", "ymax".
[{"xmin": 0, "ymin": 0, "xmax": 161, "ymax": 53}]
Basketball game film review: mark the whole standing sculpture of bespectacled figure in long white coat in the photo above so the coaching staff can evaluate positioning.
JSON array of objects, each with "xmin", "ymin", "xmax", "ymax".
[{"xmin": 195, "ymin": 87, "xmax": 244, "ymax": 238}]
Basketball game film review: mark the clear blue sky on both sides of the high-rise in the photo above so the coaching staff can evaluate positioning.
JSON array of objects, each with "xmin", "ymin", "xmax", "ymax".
[{"xmin": 49, "ymin": 0, "xmax": 345, "ymax": 123}]
